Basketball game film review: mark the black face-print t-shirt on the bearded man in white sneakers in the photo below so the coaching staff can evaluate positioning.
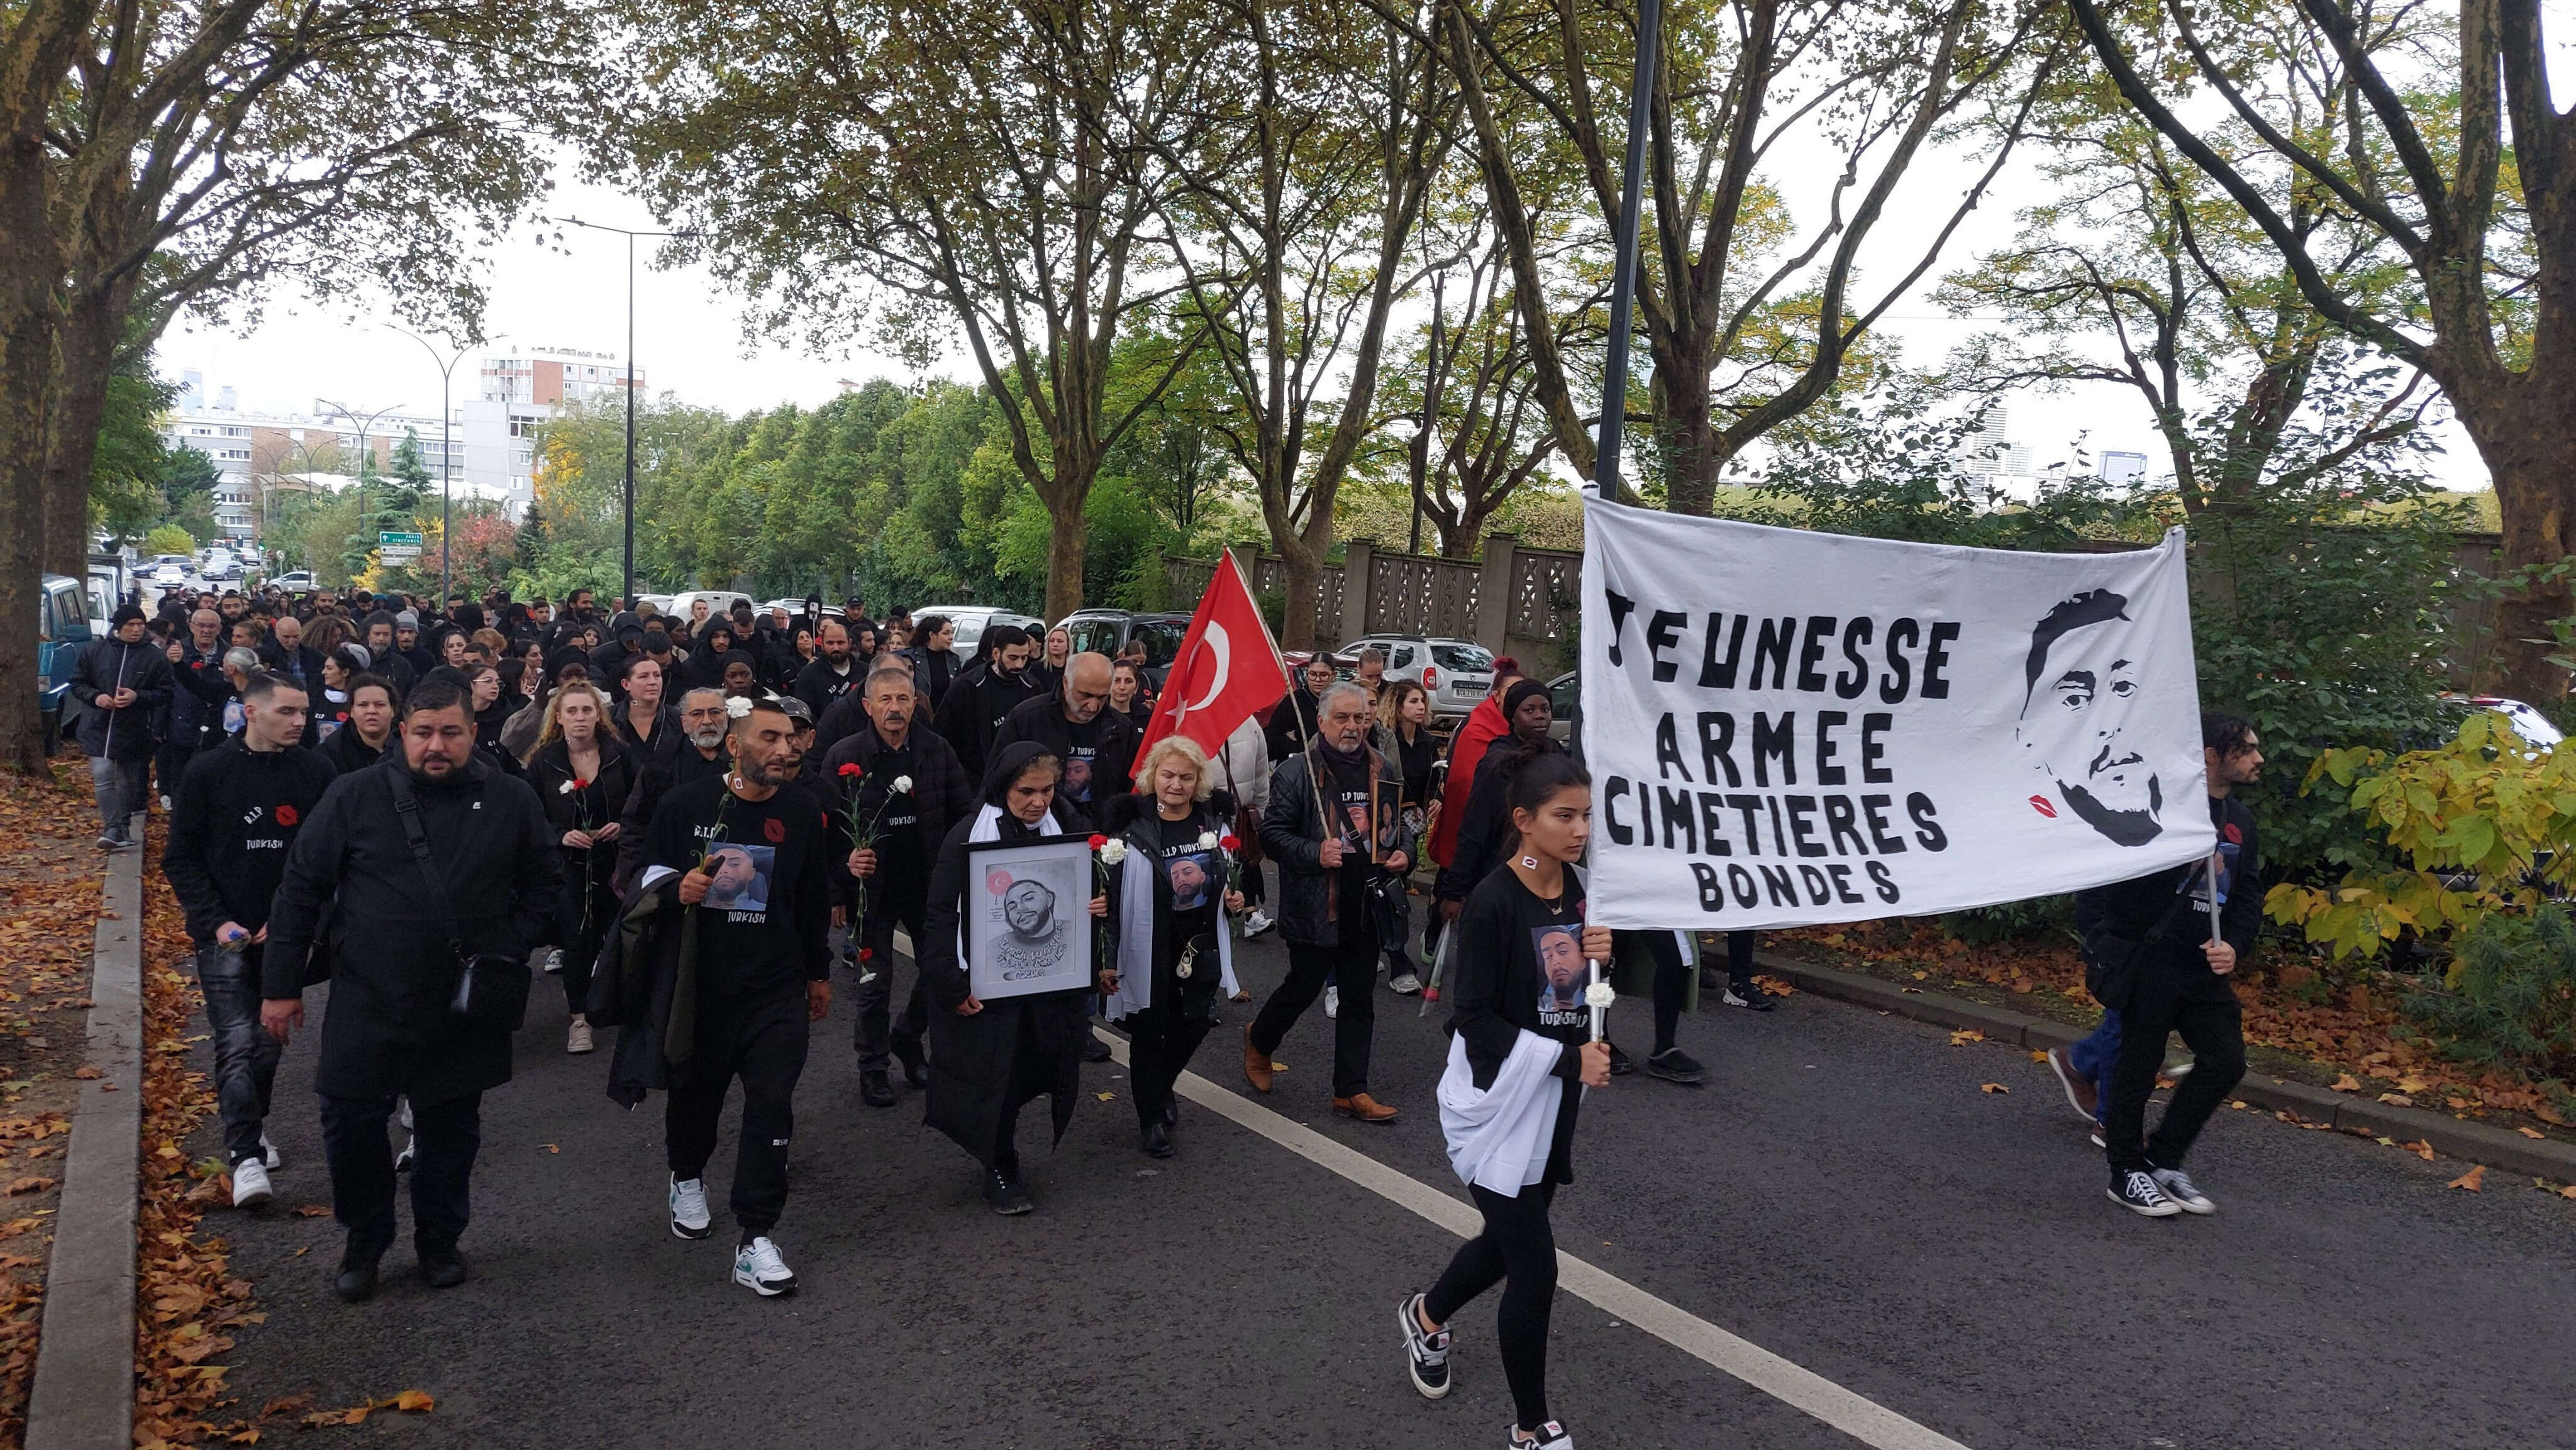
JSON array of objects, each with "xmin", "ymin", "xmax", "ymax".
[{"xmin": 644, "ymin": 775, "xmax": 832, "ymax": 997}]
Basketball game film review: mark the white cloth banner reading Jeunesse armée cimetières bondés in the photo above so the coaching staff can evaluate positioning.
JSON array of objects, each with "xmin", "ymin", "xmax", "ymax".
[{"xmin": 1582, "ymin": 500, "xmax": 2212, "ymax": 930}]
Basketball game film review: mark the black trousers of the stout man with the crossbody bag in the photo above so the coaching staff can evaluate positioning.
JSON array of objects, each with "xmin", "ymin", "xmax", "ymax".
[{"xmin": 322, "ymin": 1092, "xmax": 482, "ymax": 1265}]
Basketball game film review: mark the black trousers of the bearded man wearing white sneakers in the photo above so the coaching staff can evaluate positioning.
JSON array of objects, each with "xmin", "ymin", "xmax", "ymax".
[{"xmin": 662, "ymin": 984, "xmax": 806, "ymax": 1239}]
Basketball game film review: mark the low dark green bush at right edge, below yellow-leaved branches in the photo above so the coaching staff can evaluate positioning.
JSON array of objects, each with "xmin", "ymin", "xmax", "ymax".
[{"xmin": 2401, "ymin": 902, "xmax": 2576, "ymax": 1097}]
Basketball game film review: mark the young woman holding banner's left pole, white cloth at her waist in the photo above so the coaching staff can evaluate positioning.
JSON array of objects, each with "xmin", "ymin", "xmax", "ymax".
[{"xmin": 1396, "ymin": 755, "xmax": 1610, "ymax": 1450}]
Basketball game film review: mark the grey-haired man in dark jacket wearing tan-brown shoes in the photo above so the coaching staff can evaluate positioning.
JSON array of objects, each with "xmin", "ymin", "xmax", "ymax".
[{"xmin": 1244, "ymin": 682, "xmax": 1412, "ymax": 1123}]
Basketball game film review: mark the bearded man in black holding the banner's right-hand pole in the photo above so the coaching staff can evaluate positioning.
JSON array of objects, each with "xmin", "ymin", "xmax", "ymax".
[{"xmin": 2076, "ymin": 711, "xmax": 2262, "ymax": 1218}]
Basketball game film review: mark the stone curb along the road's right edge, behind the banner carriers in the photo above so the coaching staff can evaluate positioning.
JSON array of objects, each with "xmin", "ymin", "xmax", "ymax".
[{"xmin": 1762, "ymin": 953, "xmax": 2576, "ymax": 1190}]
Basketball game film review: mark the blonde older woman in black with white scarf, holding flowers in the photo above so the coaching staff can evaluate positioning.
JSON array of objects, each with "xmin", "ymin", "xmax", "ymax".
[{"xmin": 1100, "ymin": 736, "xmax": 1244, "ymax": 1159}]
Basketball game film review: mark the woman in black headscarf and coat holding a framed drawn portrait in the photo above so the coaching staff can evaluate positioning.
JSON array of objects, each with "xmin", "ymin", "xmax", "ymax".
[{"xmin": 914, "ymin": 739, "xmax": 1108, "ymax": 1213}]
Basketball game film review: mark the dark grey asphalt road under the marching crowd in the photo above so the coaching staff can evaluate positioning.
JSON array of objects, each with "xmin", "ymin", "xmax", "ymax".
[{"xmin": 196, "ymin": 906, "xmax": 2576, "ymax": 1450}]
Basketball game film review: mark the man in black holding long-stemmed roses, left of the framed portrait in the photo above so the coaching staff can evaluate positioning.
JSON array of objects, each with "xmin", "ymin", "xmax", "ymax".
[{"xmin": 822, "ymin": 660, "xmax": 974, "ymax": 1107}]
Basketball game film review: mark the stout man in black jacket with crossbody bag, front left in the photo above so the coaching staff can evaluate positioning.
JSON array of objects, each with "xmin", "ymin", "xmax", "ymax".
[{"xmin": 260, "ymin": 675, "xmax": 562, "ymax": 1303}]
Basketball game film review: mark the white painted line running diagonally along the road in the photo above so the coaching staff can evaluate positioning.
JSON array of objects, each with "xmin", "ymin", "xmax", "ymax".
[{"xmin": 1092, "ymin": 1027, "xmax": 1968, "ymax": 1450}]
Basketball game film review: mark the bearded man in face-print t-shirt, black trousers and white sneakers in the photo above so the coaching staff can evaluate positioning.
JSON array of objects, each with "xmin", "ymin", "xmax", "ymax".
[{"xmin": 611, "ymin": 700, "xmax": 832, "ymax": 1298}]
